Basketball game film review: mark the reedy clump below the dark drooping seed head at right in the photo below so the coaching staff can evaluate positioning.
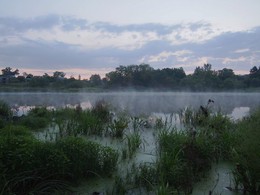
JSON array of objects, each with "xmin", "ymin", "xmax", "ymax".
[{"xmin": 179, "ymin": 108, "xmax": 236, "ymax": 161}]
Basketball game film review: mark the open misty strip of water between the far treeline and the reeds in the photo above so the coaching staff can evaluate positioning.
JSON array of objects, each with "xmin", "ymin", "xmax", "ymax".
[{"xmin": 0, "ymin": 92, "xmax": 260, "ymax": 115}]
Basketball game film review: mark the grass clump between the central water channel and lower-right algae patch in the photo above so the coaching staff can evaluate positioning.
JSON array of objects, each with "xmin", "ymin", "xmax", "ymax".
[{"xmin": 156, "ymin": 125, "xmax": 221, "ymax": 194}]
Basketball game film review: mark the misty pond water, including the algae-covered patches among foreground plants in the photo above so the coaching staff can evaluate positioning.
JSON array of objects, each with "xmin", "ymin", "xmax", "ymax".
[{"xmin": 0, "ymin": 92, "xmax": 260, "ymax": 194}]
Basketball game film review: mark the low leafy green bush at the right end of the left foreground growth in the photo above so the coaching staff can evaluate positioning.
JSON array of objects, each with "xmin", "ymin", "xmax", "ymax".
[{"xmin": 57, "ymin": 137, "xmax": 118, "ymax": 180}]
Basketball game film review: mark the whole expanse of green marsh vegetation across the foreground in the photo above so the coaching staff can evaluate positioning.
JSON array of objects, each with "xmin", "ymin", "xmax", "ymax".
[{"xmin": 0, "ymin": 101, "xmax": 260, "ymax": 195}]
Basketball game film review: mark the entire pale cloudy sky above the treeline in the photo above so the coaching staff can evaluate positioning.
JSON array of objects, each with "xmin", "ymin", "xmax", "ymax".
[{"xmin": 0, "ymin": 0, "xmax": 260, "ymax": 78}]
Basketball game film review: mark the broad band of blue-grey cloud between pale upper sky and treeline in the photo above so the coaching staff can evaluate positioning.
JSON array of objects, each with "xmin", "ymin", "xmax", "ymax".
[{"xmin": 0, "ymin": 15, "xmax": 260, "ymax": 76}]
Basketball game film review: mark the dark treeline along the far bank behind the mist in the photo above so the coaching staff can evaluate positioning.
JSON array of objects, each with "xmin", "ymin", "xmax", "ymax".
[{"xmin": 0, "ymin": 64, "xmax": 260, "ymax": 91}]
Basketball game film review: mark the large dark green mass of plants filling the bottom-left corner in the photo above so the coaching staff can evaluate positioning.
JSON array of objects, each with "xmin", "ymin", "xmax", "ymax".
[{"xmin": 0, "ymin": 126, "xmax": 118, "ymax": 194}]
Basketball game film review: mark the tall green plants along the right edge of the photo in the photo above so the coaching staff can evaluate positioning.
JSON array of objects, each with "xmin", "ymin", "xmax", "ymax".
[{"xmin": 233, "ymin": 108, "xmax": 260, "ymax": 194}]
